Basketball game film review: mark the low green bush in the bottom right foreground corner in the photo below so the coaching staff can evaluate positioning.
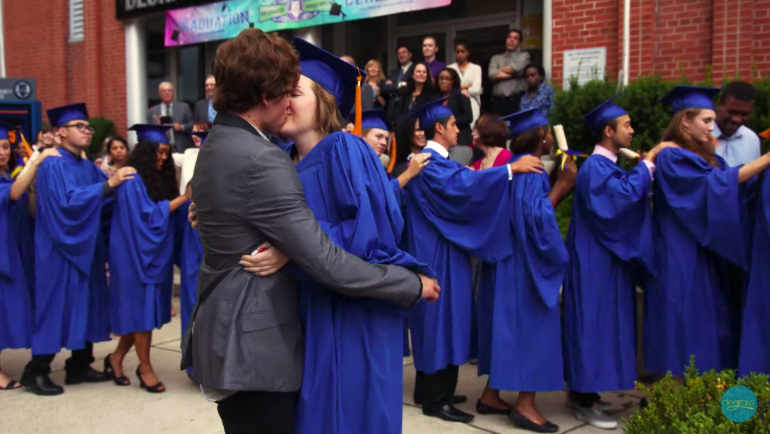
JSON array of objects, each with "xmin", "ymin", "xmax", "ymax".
[{"xmin": 624, "ymin": 356, "xmax": 770, "ymax": 434}]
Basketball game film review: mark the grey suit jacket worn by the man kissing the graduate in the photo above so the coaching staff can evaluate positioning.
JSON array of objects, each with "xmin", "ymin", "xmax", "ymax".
[{"xmin": 182, "ymin": 113, "xmax": 422, "ymax": 392}]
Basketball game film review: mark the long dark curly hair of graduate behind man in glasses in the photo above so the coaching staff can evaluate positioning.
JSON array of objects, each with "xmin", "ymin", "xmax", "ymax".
[{"xmin": 128, "ymin": 140, "xmax": 179, "ymax": 202}]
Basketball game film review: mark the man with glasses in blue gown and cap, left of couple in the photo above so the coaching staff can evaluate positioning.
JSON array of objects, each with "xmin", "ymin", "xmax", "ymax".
[{"xmin": 21, "ymin": 104, "xmax": 130, "ymax": 395}]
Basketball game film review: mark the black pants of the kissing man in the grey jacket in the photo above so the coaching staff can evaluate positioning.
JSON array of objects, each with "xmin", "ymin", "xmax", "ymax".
[{"xmin": 217, "ymin": 392, "xmax": 299, "ymax": 434}]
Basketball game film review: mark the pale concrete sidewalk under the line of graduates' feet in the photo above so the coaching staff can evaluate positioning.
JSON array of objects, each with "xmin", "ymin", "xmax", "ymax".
[{"xmin": 0, "ymin": 300, "xmax": 642, "ymax": 434}]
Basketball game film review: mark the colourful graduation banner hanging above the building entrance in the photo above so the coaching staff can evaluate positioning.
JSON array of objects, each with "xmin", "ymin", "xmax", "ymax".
[{"xmin": 165, "ymin": 0, "xmax": 452, "ymax": 47}]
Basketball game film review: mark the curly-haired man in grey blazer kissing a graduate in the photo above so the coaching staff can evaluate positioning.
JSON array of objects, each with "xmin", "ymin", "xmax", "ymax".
[{"xmin": 182, "ymin": 29, "xmax": 439, "ymax": 434}]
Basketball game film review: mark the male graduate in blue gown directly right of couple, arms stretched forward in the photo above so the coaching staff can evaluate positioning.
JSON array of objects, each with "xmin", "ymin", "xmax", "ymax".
[{"xmin": 405, "ymin": 100, "xmax": 542, "ymax": 422}]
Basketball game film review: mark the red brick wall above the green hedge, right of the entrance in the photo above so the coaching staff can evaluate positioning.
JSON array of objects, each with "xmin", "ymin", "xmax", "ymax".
[{"xmin": 551, "ymin": 0, "xmax": 770, "ymax": 86}]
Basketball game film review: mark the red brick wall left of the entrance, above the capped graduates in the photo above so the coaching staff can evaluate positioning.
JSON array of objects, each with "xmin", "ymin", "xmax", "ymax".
[{"xmin": 3, "ymin": 0, "xmax": 127, "ymax": 136}]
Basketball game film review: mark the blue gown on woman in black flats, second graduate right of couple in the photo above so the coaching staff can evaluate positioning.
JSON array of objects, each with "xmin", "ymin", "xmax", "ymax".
[{"xmin": 478, "ymin": 155, "xmax": 567, "ymax": 392}]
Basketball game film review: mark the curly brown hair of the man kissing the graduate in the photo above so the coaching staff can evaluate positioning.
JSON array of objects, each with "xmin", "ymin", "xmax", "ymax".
[{"xmin": 213, "ymin": 29, "xmax": 299, "ymax": 113}]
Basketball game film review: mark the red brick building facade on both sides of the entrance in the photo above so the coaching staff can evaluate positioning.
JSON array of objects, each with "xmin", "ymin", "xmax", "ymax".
[{"xmin": 2, "ymin": 0, "xmax": 770, "ymax": 134}]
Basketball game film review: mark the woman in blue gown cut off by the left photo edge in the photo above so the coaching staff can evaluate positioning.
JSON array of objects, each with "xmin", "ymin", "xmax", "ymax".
[{"xmin": 0, "ymin": 130, "xmax": 59, "ymax": 391}]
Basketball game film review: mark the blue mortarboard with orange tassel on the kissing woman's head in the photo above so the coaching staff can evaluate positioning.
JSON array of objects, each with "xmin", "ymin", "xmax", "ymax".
[{"xmin": 294, "ymin": 36, "xmax": 366, "ymax": 117}]
